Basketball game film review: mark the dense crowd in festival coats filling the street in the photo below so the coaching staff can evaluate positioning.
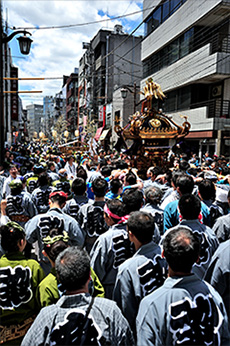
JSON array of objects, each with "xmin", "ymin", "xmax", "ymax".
[{"xmin": 0, "ymin": 143, "xmax": 230, "ymax": 346}]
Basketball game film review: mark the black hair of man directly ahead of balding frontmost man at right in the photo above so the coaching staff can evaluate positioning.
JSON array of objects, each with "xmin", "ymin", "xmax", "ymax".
[{"xmin": 178, "ymin": 193, "xmax": 201, "ymax": 220}]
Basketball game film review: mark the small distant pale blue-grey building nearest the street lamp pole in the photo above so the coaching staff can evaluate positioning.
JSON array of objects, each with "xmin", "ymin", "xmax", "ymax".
[{"xmin": 26, "ymin": 104, "xmax": 44, "ymax": 138}]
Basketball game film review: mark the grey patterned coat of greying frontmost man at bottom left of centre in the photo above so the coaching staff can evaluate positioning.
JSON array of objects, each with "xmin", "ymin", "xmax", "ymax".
[{"xmin": 22, "ymin": 293, "xmax": 134, "ymax": 346}]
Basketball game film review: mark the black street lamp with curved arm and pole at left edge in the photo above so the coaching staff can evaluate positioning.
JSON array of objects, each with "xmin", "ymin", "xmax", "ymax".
[{"xmin": 0, "ymin": 7, "xmax": 32, "ymax": 162}]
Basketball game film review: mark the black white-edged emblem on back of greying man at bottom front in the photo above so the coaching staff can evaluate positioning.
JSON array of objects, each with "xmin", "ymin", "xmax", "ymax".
[{"xmin": 50, "ymin": 298, "xmax": 102, "ymax": 346}]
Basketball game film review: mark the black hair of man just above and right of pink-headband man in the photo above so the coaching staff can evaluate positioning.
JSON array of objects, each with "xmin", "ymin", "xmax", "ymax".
[{"xmin": 122, "ymin": 189, "xmax": 143, "ymax": 214}]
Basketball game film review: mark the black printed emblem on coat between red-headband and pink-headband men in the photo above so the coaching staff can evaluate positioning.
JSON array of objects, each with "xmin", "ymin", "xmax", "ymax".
[{"xmin": 83, "ymin": 204, "xmax": 108, "ymax": 237}]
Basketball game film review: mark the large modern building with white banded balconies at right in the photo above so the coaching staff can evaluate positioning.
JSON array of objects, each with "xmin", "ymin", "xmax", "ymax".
[{"xmin": 141, "ymin": 0, "xmax": 230, "ymax": 156}]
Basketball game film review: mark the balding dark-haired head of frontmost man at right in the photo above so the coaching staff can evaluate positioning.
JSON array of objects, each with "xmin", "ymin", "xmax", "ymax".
[{"xmin": 163, "ymin": 226, "xmax": 200, "ymax": 273}]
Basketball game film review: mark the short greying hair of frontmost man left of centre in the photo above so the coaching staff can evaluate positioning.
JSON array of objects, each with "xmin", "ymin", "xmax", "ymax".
[{"xmin": 55, "ymin": 246, "xmax": 90, "ymax": 291}]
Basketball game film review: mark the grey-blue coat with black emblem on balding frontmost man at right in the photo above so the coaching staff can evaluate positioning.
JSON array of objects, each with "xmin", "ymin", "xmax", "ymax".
[{"xmin": 137, "ymin": 274, "xmax": 230, "ymax": 346}]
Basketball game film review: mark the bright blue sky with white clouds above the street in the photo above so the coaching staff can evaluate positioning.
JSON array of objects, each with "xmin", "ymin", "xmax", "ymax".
[{"xmin": 2, "ymin": 0, "xmax": 143, "ymax": 108}]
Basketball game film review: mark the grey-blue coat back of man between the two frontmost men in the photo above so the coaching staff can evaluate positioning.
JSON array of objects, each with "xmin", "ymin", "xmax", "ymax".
[{"xmin": 113, "ymin": 242, "xmax": 167, "ymax": 330}]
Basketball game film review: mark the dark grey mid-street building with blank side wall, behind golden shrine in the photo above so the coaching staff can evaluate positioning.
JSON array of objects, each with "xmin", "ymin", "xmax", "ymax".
[{"xmin": 78, "ymin": 25, "xmax": 142, "ymax": 146}]
